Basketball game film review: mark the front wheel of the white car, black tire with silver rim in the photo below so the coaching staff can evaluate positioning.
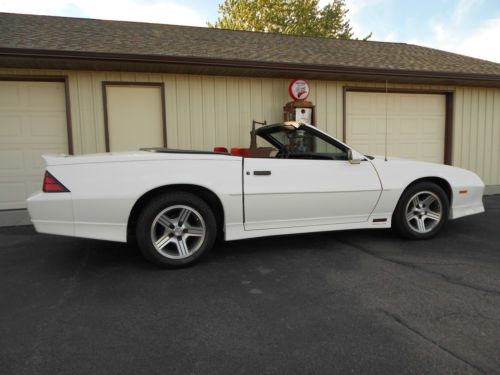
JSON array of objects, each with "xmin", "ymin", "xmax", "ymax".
[{"xmin": 392, "ymin": 181, "xmax": 450, "ymax": 240}]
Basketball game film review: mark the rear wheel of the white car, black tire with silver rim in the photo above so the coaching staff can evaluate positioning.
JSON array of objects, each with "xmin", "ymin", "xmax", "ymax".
[{"xmin": 136, "ymin": 191, "xmax": 217, "ymax": 268}]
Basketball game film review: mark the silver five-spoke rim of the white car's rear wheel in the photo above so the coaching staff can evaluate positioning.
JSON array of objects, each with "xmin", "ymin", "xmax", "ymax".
[{"xmin": 151, "ymin": 205, "xmax": 206, "ymax": 259}]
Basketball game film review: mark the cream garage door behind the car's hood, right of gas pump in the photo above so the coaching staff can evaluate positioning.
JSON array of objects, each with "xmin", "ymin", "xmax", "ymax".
[{"xmin": 346, "ymin": 91, "xmax": 446, "ymax": 163}]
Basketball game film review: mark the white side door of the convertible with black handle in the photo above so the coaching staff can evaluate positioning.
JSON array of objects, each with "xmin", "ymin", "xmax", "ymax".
[{"xmin": 243, "ymin": 128, "xmax": 381, "ymax": 230}]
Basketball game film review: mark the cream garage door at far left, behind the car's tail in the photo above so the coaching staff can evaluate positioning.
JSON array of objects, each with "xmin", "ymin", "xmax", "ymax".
[{"xmin": 0, "ymin": 81, "xmax": 68, "ymax": 210}]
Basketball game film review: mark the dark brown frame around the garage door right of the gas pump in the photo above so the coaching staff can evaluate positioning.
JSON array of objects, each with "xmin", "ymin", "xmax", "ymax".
[{"xmin": 342, "ymin": 86, "xmax": 455, "ymax": 165}]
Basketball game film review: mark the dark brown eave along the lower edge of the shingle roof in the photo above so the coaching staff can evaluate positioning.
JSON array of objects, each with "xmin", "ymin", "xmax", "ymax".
[{"xmin": 0, "ymin": 48, "xmax": 500, "ymax": 87}]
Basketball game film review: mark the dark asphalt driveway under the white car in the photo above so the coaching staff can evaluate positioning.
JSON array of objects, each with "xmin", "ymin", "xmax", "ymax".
[{"xmin": 0, "ymin": 196, "xmax": 500, "ymax": 374}]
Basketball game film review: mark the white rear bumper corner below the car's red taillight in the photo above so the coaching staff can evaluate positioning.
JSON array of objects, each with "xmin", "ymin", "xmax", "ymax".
[{"xmin": 27, "ymin": 192, "xmax": 75, "ymax": 236}]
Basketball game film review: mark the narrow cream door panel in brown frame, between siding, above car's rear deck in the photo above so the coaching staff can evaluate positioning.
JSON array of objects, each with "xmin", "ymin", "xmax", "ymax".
[{"xmin": 106, "ymin": 84, "xmax": 164, "ymax": 151}]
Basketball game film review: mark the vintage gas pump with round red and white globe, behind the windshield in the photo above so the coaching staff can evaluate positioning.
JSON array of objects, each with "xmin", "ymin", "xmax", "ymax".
[{"xmin": 283, "ymin": 79, "xmax": 315, "ymax": 125}]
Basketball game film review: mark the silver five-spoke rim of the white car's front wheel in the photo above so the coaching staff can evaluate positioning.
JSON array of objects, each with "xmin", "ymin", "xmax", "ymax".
[{"xmin": 405, "ymin": 191, "xmax": 443, "ymax": 233}]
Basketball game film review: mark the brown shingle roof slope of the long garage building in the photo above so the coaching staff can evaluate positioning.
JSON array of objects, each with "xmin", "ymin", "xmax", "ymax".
[{"xmin": 0, "ymin": 13, "xmax": 500, "ymax": 80}]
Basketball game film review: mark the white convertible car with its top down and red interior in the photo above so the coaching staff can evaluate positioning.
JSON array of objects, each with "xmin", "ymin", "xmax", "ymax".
[{"xmin": 28, "ymin": 122, "xmax": 484, "ymax": 267}]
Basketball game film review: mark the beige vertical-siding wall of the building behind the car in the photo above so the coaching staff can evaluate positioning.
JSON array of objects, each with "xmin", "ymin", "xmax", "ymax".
[{"xmin": 0, "ymin": 69, "xmax": 500, "ymax": 185}]
